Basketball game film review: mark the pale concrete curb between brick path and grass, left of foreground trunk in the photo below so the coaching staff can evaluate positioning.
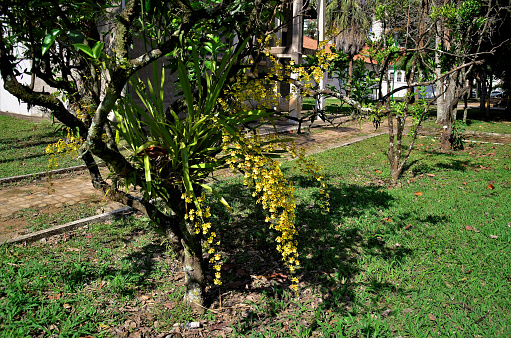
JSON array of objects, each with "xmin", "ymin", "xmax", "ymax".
[{"xmin": 0, "ymin": 207, "xmax": 133, "ymax": 245}]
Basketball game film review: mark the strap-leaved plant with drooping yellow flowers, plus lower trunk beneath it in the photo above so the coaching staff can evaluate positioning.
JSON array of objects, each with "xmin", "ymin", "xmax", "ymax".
[{"xmin": 115, "ymin": 40, "xmax": 322, "ymax": 304}]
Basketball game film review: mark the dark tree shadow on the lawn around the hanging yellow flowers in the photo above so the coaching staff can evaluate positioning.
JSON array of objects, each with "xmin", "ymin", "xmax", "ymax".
[{"xmin": 208, "ymin": 177, "xmax": 413, "ymax": 330}]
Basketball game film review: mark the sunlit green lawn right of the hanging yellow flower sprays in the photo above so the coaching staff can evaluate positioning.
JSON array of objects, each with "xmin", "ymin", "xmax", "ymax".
[{"xmin": 210, "ymin": 137, "xmax": 511, "ymax": 337}]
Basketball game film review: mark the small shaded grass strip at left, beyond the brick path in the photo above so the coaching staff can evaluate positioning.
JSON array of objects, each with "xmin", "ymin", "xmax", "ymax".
[{"xmin": 0, "ymin": 115, "xmax": 83, "ymax": 177}]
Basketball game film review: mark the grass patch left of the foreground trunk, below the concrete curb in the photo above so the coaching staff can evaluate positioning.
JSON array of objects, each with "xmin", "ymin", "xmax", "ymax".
[{"xmin": 0, "ymin": 218, "xmax": 191, "ymax": 338}]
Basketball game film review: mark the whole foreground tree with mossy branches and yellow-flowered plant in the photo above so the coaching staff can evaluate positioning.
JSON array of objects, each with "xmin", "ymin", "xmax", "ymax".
[{"xmin": 0, "ymin": 0, "xmax": 328, "ymax": 306}]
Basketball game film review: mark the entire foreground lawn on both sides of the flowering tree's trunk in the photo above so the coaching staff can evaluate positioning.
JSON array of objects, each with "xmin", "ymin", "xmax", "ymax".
[{"xmin": 0, "ymin": 132, "xmax": 511, "ymax": 337}]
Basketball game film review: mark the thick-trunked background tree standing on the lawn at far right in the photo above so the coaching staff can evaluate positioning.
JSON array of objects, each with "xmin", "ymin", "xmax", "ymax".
[{"xmin": 432, "ymin": 0, "xmax": 502, "ymax": 150}]
